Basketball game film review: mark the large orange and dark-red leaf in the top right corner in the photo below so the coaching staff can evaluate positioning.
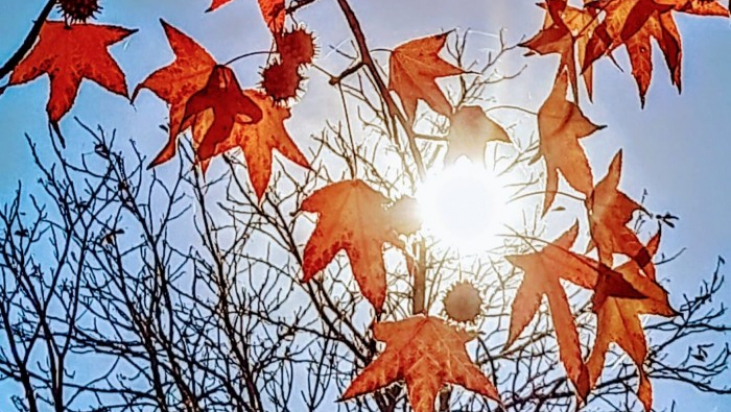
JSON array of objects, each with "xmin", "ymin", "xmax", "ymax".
[{"xmin": 583, "ymin": 0, "xmax": 729, "ymax": 106}]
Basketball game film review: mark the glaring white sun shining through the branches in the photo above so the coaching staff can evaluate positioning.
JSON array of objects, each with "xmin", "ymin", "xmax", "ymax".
[{"xmin": 416, "ymin": 158, "xmax": 509, "ymax": 253}]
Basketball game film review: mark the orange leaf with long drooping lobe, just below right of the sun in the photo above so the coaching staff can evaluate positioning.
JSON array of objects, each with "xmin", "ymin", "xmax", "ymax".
[{"xmin": 505, "ymin": 223, "xmax": 597, "ymax": 399}]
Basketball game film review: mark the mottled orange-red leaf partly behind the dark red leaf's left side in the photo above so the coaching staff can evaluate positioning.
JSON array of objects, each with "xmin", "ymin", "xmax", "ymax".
[{"xmin": 132, "ymin": 20, "xmax": 216, "ymax": 167}]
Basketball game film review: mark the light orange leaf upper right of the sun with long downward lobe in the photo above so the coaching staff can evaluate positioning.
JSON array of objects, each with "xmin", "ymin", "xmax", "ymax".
[{"xmin": 538, "ymin": 72, "xmax": 604, "ymax": 215}]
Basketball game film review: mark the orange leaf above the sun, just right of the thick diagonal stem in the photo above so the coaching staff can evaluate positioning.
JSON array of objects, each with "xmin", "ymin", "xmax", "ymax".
[{"xmin": 388, "ymin": 33, "xmax": 464, "ymax": 123}]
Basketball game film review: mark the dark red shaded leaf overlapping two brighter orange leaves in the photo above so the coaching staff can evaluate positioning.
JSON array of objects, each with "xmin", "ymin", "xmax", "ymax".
[{"xmin": 180, "ymin": 65, "xmax": 263, "ymax": 161}]
